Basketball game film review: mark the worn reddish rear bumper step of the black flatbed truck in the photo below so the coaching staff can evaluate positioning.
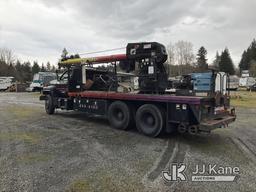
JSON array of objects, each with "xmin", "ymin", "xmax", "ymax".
[{"xmin": 199, "ymin": 109, "xmax": 236, "ymax": 132}]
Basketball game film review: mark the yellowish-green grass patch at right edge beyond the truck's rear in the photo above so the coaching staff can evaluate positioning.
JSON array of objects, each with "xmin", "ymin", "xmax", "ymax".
[{"xmin": 231, "ymin": 91, "xmax": 256, "ymax": 108}]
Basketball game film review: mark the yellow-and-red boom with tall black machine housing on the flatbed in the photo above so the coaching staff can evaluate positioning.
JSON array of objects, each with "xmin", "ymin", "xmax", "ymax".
[{"xmin": 59, "ymin": 42, "xmax": 168, "ymax": 93}]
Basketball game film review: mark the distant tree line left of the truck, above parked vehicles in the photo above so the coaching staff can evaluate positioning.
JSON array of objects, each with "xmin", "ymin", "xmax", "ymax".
[{"xmin": 0, "ymin": 48, "xmax": 56, "ymax": 83}]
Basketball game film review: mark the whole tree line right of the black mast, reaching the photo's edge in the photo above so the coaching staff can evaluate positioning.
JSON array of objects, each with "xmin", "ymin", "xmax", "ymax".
[{"xmin": 166, "ymin": 39, "xmax": 256, "ymax": 77}]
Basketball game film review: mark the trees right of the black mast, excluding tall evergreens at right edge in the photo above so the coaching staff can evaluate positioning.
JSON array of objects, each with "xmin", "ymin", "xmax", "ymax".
[{"xmin": 166, "ymin": 41, "xmax": 236, "ymax": 76}]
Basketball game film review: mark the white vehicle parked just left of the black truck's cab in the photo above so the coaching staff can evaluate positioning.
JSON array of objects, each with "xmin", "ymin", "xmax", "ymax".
[{"xmin": 27, "ymin": 72, "xmax": 57, "ymax": 92}]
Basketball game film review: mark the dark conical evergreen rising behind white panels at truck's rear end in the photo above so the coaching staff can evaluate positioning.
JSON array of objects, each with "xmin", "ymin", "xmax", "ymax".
[{"xmin": 219, "ymin": 48, "xmax": 235, "ymax": 75}]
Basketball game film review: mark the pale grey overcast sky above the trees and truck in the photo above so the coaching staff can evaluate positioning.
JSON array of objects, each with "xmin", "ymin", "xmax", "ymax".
[{"xmin": 0, "ymin": 0, "xmax": 256, "ymax": 64}]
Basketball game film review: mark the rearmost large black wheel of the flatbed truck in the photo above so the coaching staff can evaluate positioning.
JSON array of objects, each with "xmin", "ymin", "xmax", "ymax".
[{"xmin": 136, "ymin": 104, "xmax": 165, "ymax": 137}]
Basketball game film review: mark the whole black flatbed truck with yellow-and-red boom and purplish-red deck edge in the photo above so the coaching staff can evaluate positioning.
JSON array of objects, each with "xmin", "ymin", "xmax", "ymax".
[{"xmin": 40, "ymin": 42, "xmax": 236, "ymax": 137}]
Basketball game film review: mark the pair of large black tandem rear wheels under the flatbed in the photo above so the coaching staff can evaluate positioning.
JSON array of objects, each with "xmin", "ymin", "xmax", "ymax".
[{"xmin": 108, "ymin": 101, "xmax": 165, "ymax": 137}]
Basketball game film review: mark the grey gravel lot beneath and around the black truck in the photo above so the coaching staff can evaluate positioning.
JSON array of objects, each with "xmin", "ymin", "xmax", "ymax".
[{"xmin": 0, "ymin": 93, "xmax": 256, "ymax": 192}]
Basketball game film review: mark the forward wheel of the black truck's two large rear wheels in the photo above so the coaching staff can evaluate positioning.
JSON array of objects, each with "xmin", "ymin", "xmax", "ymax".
[{"xmin": 108, "ymin": 101, "xmax": 132, "ymax": 130}]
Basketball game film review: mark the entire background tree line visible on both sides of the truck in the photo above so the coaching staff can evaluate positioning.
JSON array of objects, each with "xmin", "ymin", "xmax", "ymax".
[{"xmin": 0, "ymin": 39, "xmax": 256, "ymax": 82}]
